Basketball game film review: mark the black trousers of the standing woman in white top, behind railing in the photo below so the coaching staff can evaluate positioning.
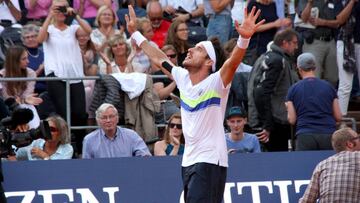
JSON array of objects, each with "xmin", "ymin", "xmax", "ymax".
[{"xmin": 47, "ymin": 78, "xmax": 87, "ymax": 153}]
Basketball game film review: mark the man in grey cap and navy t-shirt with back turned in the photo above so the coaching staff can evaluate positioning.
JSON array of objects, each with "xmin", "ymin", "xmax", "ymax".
[{"xmin": 286, "ymin": 53, "xmax": 341, "ymax": 151}]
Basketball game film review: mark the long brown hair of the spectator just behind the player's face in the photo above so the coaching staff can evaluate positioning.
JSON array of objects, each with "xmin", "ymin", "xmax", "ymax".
[{"xmin": 164, "ymin": 20, "xmax": 190, "ymax": 54}]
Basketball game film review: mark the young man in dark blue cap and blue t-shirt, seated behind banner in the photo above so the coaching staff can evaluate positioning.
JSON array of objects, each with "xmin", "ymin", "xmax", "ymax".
[{"xmin": 225, "ymin": 106, "xmax": 261, "ymax": 154}]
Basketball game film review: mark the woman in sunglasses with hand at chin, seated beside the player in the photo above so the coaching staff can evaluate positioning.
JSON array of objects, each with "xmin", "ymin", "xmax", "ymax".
[{"xmin": 154, "ymin": 113, "xmax": 184, "ymax": 156}]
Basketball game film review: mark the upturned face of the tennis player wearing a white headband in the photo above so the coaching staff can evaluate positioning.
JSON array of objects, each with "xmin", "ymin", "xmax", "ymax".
[{"xmin": 183, "ymin": 43, "xmax": 211, "ymax": 69}]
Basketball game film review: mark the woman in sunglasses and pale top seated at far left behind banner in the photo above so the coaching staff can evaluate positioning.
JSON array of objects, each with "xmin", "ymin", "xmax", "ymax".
[{"xmin": 12, "ymin": 116, "xmax": 74, "ymax": 160}]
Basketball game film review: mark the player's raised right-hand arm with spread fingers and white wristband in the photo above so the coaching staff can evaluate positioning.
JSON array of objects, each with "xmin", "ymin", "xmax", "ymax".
[{"xmin": 220, "ymin": 6, "xmax": 265, "ymax": 86}]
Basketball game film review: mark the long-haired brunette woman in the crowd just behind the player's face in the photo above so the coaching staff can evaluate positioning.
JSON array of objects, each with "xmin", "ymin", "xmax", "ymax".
[{"xmin": 165, "ymin": 20, "xmax": 190, "ymax": 66}]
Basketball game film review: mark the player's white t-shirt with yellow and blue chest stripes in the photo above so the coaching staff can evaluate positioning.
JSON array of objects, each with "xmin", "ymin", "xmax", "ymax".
[{"xmin": 171, "ymin": 67, "xmax": 230, "ymax": 167}]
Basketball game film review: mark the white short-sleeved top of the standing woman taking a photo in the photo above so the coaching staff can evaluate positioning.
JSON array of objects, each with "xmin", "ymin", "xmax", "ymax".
[{"xmin": 43, "ymin": 25, "xmax": 84, "ymax": 83}]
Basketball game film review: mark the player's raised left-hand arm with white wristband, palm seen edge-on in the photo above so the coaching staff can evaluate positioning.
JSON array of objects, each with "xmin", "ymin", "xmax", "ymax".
[{"xmin": 125, "ymin": 5, "xmax": 174, "ymax": 78}]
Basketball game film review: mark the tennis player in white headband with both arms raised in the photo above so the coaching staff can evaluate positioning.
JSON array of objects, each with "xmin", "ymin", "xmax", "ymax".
[{"xmin": 126, "ymin": 3, "xmax": 264, "ymax": 203}]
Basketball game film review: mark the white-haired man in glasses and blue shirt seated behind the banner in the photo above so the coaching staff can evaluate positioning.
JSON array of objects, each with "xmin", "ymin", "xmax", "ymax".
[{"xmin": 82, "ymin": 103, "xmax": 151, "ymax": 159}]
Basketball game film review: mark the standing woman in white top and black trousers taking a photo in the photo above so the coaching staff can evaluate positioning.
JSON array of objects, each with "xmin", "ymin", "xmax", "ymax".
[{"xmin": 37, "ymin": 0, "xmax": 91, "ymax": 152}]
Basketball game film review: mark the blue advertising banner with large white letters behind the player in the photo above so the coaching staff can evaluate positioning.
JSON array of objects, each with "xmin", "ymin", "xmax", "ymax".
[{"xmin": 3, "ymin": 151, "xmax": 334, "ymax": 203}]
